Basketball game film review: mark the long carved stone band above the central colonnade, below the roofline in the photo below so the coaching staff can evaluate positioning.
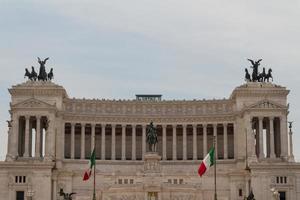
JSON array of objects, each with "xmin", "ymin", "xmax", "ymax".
[{"xmin": 64, "ymin": 99, "xmax": 235, "ymax": 116}]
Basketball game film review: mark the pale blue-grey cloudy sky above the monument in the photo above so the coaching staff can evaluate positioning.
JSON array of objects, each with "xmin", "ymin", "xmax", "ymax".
[{"xmin": 0, "ymin": 0, "xmax": 300, "ymax": 160}]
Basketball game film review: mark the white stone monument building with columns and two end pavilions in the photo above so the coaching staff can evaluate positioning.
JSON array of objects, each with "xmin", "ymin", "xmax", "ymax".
[{"xmin": 0, "ymin": 59, "xmax": 300, "ymax": 200}]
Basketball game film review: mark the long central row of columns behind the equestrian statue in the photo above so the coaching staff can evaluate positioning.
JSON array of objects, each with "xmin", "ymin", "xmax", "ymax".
[{"xmin": 64, "ymin": 122, "xmax": 234, "ymax": 160}]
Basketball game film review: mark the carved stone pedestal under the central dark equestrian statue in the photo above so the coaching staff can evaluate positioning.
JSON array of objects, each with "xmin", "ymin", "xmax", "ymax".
[{"xmin": 144, "ymin": 152, "xmax": 161, "ymax": 174}]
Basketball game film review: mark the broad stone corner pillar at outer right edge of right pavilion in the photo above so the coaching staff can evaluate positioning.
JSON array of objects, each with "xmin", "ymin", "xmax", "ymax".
[{"xmin": 280, "ymin": 116, "xmax": 288, "ymax": 159}]
